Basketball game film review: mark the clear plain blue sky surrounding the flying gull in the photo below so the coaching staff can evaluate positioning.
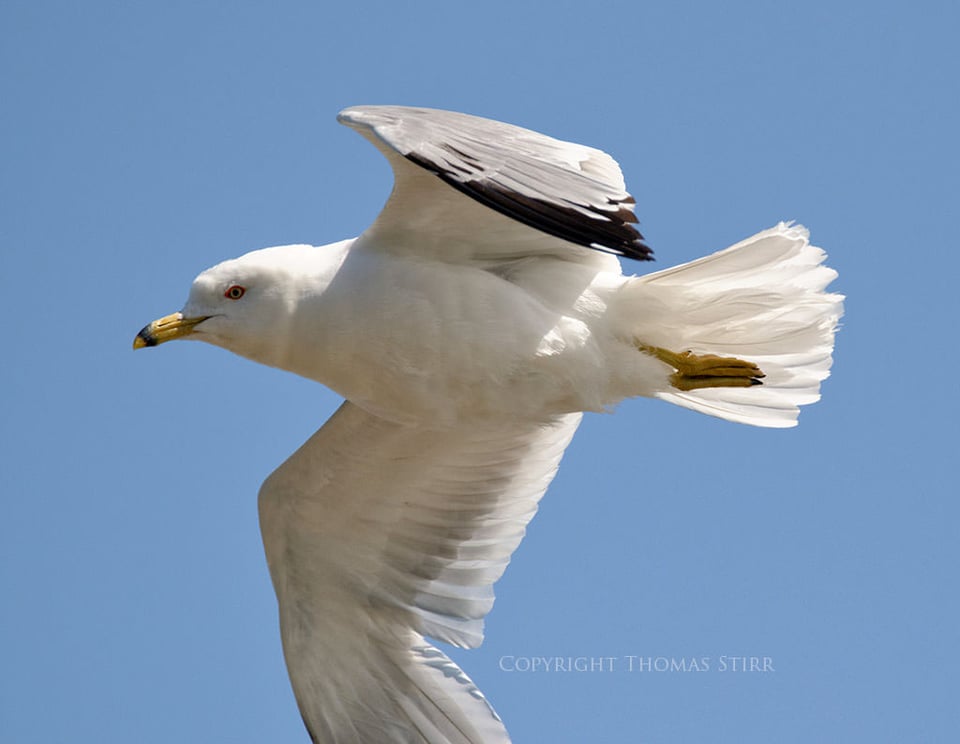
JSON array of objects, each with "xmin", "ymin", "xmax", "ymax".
[{"xmin": 0, "ymin": 0, "xmax": 960, "ymax": 744}]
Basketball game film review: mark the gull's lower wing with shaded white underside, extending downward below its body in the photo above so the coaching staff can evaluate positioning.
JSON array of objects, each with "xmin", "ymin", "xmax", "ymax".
[{"xmin": 260, "ymin": 402, "xmax": 580, "ymax": 743}]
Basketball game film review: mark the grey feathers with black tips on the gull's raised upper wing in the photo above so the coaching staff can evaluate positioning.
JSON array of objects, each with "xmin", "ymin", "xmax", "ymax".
[{"xmin": 338, "ymin": 106, "xmax": 653, "ymax": 259}]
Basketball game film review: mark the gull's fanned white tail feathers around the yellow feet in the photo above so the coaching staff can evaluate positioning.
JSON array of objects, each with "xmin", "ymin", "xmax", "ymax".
[{"xmin": 625, "ymin": 222, "xmax": 844, "ymax": 428}]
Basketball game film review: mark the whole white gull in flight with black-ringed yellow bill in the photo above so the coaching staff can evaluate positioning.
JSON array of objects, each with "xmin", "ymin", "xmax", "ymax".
[{"xmin": 134, "ymin": 106, "xmax": 843, "ymax": 744}]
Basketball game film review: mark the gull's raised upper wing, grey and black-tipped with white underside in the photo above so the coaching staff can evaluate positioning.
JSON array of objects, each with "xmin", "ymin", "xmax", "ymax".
[{"xmin": 337, "ymin": 106, "xmax": 653, "ymax": 263}]
